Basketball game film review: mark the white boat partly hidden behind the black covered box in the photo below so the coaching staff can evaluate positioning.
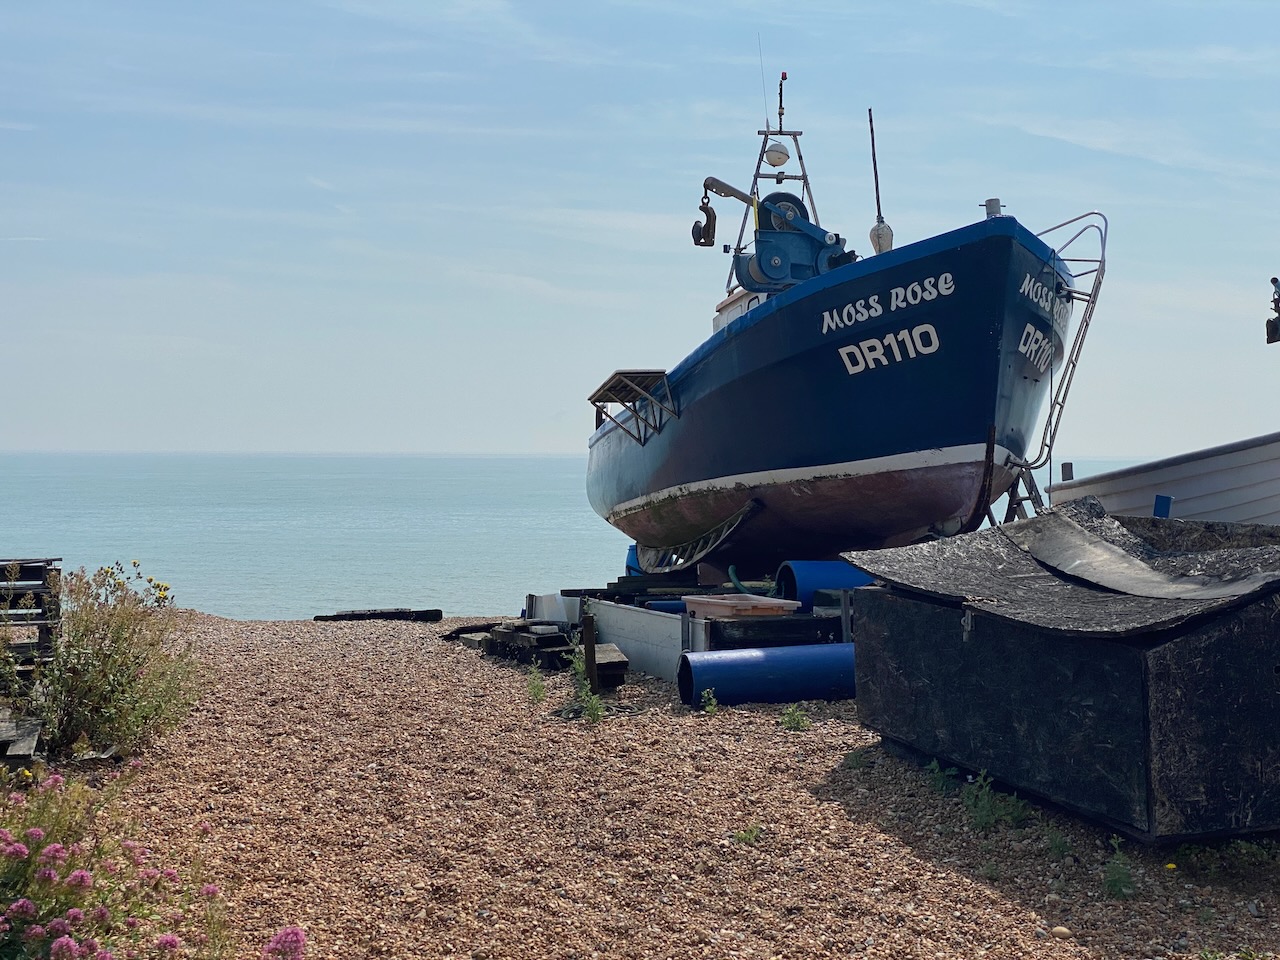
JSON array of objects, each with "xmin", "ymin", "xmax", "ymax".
[{"xmin": 1050, "ymin": 433, "xmax": 1280, "ymax": 524}]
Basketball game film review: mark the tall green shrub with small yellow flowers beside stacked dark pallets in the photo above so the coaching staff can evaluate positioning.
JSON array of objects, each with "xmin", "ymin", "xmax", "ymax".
[{"xmin": 29, "ymin": 561, "xmax": 200, "ymax": 755}]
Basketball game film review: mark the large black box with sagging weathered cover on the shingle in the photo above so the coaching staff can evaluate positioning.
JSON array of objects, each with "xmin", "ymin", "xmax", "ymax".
[{"xmin": 846, "ymin": 499, "xmax": 1280, "ymax": 840}]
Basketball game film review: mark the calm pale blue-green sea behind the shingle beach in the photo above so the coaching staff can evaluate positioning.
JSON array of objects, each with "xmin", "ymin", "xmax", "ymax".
[{"xmin": 0, "ymin": 453, "xmax": 1133, "ymax": 620}]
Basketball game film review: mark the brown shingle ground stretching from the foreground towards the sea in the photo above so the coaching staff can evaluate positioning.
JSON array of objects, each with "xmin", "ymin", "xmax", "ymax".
[{"xmin": 115, "ymin": 616, "xmax": 1280, "ymax": 960}]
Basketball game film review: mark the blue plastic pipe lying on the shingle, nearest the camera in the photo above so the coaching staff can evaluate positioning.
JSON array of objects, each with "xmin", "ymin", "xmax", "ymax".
[{"xmin": 676, "ymin": 644, "xmax": 854, "ymax": 707}]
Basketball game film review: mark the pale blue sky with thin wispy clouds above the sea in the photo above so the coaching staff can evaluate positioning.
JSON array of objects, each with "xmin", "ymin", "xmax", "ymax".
[{"xmin": 0, "ymin": 0, "xmax": 1280, "ymax": 460}]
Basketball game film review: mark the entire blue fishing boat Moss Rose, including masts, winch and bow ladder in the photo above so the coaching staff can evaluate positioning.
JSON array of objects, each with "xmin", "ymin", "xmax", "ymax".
[{"xmin": 586, "ymin": 74, "xmax": 1106, "ymax": 573}]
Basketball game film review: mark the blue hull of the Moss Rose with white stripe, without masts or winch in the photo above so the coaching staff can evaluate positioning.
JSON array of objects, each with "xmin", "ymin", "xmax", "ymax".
[{"xmin": 586, "ymin": 216, "xmax": 1071, "ymax": 570}]
